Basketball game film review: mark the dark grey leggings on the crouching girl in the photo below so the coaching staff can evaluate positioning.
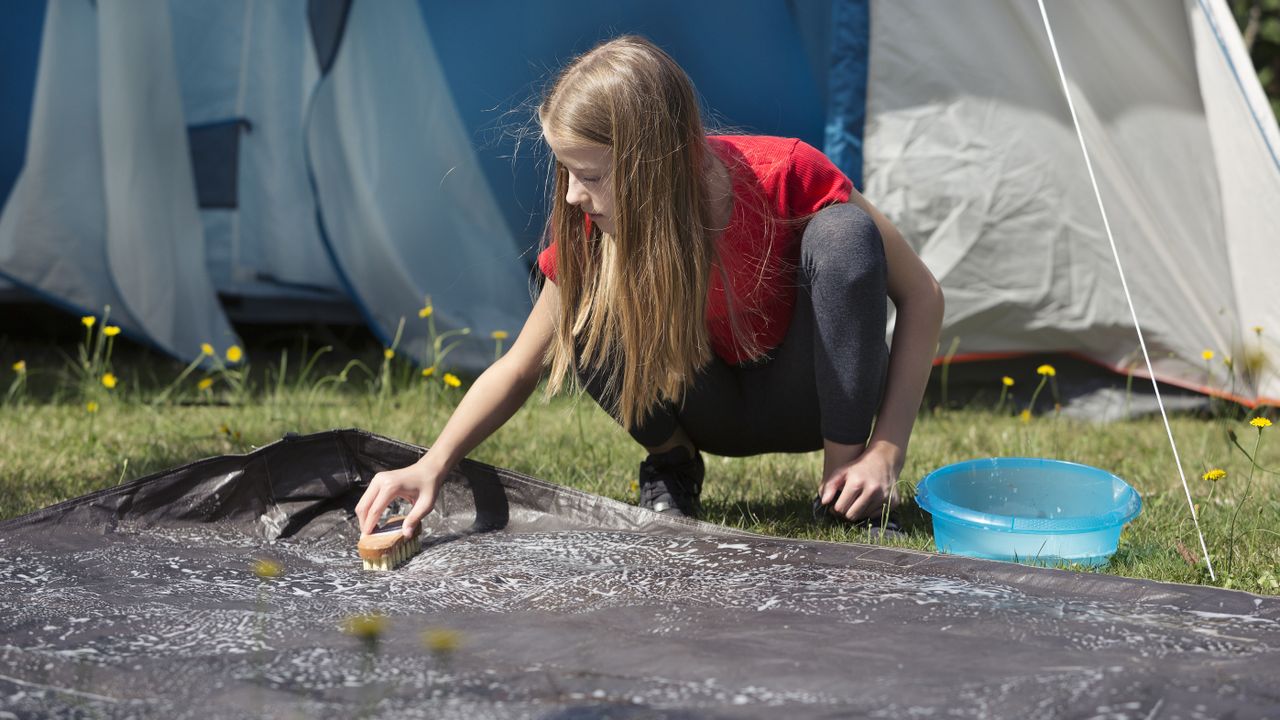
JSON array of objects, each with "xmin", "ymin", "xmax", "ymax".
[{"xmin": 579, "ymin": 204, "xmax": 888, "ymax": 456}]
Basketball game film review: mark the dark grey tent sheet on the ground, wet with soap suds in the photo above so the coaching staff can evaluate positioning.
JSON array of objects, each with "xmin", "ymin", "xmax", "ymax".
[{"xmin": 0, "ymin": 430, "xmax": 1280, "ymax": 719}]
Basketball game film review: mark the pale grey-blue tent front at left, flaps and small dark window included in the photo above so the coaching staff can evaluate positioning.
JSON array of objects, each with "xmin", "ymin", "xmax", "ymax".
[{"xmin": 0, "ymin": 0, "xmax": 530, "ymax": 370}]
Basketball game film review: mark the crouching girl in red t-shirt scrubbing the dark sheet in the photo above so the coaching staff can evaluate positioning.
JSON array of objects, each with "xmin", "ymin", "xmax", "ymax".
[{"xmin": 356, "ymin": 36, "xmax": 942, "ymax": 534}]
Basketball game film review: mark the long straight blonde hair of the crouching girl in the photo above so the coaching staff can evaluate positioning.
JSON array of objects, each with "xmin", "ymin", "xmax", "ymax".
[{"xmin": 538, "ymin": 36, "xmax": 762, "ymax": 429}]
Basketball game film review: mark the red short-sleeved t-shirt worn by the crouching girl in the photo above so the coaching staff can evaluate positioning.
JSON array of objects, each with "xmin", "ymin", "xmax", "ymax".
[{"xmin": 538, "ymin": 136, "xmax": 852, "ymax": 365}]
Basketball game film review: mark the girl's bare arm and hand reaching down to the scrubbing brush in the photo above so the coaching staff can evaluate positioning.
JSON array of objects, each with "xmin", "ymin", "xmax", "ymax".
[{"xmin": 356, "ymin": 281, "xmax": 559, "ymax": 536}]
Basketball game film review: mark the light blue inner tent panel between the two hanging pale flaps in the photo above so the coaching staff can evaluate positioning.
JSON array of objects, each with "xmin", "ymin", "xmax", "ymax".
[{"xmin": 169, "ymin": 0, "xmax": 347, "ymax": 301}]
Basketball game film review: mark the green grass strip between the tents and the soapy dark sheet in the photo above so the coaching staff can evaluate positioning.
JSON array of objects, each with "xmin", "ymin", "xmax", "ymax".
[{"xmin": 0, "ymin": 330, "xmax": 1280, "ymax": 594}]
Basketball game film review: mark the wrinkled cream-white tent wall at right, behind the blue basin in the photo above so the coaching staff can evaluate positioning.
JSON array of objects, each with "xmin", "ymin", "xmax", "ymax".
[{"xmin": 831, "ymin": 0, "xmax": 1280, "ymax": 404}]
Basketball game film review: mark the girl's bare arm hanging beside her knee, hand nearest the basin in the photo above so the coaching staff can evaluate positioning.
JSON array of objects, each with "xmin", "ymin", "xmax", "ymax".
[{"xmin": 819, "ymin": 191, "xmax": 943, "ymax": 520}]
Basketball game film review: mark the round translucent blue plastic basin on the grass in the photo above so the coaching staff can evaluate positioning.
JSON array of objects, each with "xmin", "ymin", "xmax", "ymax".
[{"xmin": 915, "ymin": 457, "xmax": 1142, "ymax": 565}]
